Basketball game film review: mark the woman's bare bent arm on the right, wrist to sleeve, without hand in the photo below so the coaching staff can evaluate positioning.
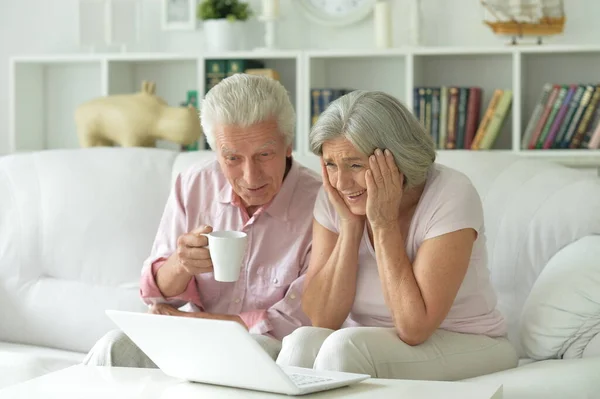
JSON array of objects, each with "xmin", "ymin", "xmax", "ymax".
[{"xmin": 373, "ymin": 227, "xmax": 477, "ymax": 345}]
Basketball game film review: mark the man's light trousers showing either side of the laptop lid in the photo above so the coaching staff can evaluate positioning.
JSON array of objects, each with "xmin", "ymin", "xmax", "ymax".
[{"xmin": 83, "ymin": 330, "xmax": 281, "ymax": 368}]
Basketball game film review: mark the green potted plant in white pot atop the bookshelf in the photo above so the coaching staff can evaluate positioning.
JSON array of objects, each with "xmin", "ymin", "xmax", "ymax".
[{"xmin": 197, "ymin": 0, "xmax": 253, "ymax": 51}]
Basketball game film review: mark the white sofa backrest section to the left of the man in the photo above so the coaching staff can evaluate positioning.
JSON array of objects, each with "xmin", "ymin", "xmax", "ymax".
[{"xmin": 0, "ymin": 148, "xmax": 176, "ymax": 352}]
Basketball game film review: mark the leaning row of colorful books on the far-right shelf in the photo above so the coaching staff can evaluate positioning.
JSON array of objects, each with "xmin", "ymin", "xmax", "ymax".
[{"xmin": 521, "ymin": 83, "xmax": 600, "ymax": 150}]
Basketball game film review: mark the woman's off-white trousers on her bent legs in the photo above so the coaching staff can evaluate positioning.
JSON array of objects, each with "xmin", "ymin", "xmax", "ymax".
[{"xmin": 277, "ymin": 327, "xmax": 518, "ymax": 381}]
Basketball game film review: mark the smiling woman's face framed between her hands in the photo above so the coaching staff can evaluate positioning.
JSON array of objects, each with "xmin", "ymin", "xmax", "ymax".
[{"xmin": 322, "ymin": 137, "xmax": 369, "ymax": 215}]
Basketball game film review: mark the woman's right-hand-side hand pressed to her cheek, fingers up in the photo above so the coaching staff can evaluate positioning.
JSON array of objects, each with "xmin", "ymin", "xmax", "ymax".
[{"xmin": 365, "ymin": 149, "xmax": 404, "ymax": 228}]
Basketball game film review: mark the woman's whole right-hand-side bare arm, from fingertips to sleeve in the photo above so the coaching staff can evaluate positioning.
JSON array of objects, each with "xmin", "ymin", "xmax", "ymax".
[{"xmin": 366, "ymin": 150, "xmax": 477, "ymax": 345}]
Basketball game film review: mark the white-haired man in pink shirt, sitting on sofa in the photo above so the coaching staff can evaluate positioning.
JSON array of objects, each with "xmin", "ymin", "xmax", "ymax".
[{"xmin": 84, "ymin": 74, "xmax": 321, "ymax": 367}]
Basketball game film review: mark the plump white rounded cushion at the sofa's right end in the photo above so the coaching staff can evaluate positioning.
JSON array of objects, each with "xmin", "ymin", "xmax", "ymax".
[{"xmin": 520, "ymin": 235, "xmax": 600, "ymax": 360}]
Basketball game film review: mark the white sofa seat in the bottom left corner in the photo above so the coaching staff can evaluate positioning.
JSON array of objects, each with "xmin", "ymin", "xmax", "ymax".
[{"xmin": 0, "ymin": 342, "xmax": 85, "ymax": 389}]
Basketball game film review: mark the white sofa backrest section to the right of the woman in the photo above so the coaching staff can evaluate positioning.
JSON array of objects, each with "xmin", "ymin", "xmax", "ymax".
[{"xmin": 438, "ymin": 151, "xmax": 600, "ymax": 357}]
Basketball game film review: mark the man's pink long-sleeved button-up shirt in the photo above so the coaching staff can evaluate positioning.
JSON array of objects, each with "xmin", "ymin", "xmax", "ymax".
[{"xmin": 140, "ymin": 161, "xmax": 321, "ymax": 339}]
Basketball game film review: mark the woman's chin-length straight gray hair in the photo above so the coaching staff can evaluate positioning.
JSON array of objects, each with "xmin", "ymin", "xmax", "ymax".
[{"xmin": 309, "ymin": 90, "xmax": 436, "ymax": 189}]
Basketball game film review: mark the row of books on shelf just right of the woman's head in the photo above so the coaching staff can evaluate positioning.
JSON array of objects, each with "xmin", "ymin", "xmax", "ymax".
[{"xmin": 413, "ymin": 86, "xmax": 512, "ymax": 150}]
